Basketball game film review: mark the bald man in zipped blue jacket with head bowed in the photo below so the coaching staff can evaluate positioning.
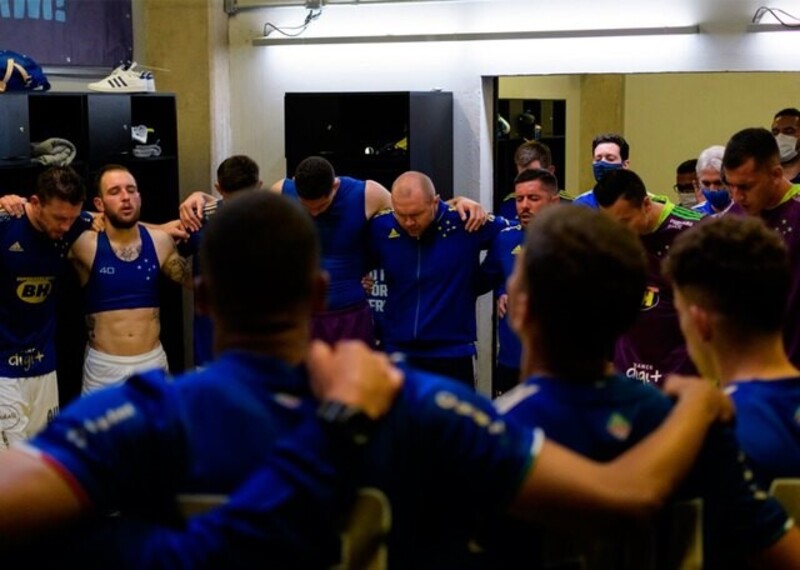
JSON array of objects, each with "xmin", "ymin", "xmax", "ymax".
[{"xmin": 370, "ymin": 171, "xmax": 507, "ymax": 388}]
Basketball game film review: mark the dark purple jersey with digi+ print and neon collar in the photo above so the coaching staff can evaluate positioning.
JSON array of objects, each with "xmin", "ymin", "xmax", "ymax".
[{"xmin": 612, "ymin": 203, "xmax": 701, "ymax": 386}]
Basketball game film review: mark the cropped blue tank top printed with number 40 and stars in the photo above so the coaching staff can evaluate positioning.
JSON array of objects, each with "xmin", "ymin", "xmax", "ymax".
[{"xmin": 84, "ymin": 226, "xmax": 160, "ymax": 314}]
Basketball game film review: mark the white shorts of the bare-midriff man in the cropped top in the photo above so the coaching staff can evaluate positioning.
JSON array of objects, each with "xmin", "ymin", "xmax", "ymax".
[{"xmin": 82, "ymin": 344, "xmax": 169, "ymax": 394}]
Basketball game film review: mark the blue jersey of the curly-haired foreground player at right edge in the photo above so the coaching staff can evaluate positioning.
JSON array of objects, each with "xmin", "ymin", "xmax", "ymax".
[{"xmin": 726, "ymin": 378, "xmax": 800, "ymax": 488}]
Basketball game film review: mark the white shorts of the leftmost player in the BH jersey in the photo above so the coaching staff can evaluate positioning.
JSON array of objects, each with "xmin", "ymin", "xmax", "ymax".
[{"xmin": 0, "ymin": 370, "xmax": 58, "ymax": 449}]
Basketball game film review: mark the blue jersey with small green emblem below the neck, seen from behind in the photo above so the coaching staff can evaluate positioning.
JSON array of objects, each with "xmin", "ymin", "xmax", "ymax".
[{"xmin": 484, "ymin": 376, "xmax": 790, "ymax": 568}]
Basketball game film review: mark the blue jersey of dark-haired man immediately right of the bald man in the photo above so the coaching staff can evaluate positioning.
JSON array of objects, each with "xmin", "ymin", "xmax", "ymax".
[{"xmin": 481, "ymin": 225, "xmax": 525, "ymax": 368}]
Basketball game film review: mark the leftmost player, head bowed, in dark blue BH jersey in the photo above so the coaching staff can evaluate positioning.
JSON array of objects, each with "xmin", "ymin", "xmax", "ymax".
[{"xmin": 0, "ymin": 166, "xmax": 91, "ymax": 451}]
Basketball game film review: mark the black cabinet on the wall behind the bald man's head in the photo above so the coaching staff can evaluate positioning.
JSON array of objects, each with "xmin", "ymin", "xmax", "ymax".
[{"xmin": 284, "ymin": 91, "xmax": 453, "ymax": 198}]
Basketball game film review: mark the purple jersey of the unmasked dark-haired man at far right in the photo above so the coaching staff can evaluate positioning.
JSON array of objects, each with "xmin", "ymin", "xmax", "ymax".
[{"xmin": 728, "ymin": 184, "xmax": 800, "ymax": 366}]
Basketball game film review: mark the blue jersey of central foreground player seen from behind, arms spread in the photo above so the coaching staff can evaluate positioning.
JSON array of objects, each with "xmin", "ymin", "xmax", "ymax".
[{"xmin": 29, "ymin": 353, "xmax": 541, "ymax": 568}]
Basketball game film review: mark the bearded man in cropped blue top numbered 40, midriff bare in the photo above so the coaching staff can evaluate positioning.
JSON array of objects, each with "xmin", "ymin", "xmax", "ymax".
[{"xmin": 69, "ymin": 164, "xmax": 192, "ymax": 394}]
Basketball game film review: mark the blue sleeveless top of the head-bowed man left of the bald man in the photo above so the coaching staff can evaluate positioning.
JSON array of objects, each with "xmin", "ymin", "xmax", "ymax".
[{"xmin": 282, "ymin": 176, "xmax": 367, "ymax": 311}]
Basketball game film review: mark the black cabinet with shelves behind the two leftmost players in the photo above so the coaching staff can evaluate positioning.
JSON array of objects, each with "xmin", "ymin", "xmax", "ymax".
[{"xmin": 0, "ymin": 93, "xmax": 184, "ymax": 404}]
